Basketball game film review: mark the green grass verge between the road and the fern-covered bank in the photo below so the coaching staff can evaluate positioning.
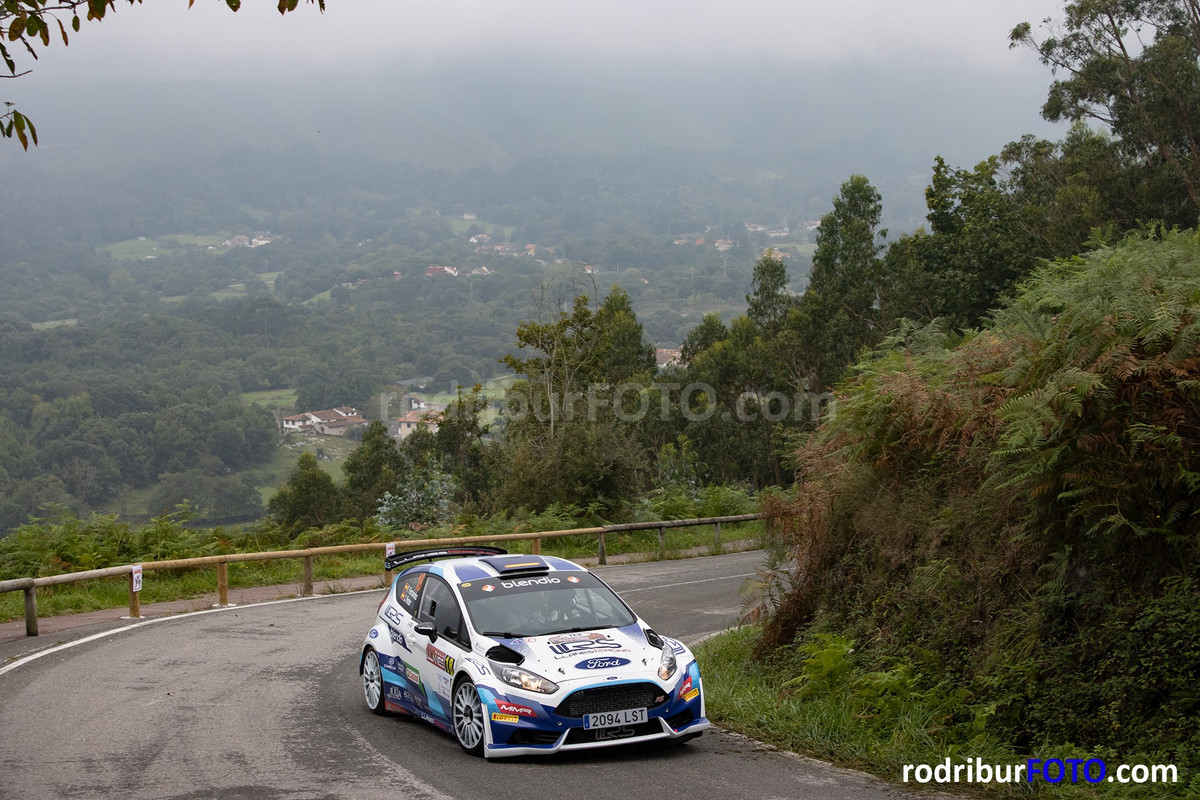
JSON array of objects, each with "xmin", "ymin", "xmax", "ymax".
[{"xmin": 695, "ymin": 626, "xmax": 1200, "ymax": 799}]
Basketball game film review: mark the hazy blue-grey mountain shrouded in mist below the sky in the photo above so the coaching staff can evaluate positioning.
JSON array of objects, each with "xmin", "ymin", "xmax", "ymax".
[{"xmin": 0, "ymin": 58, "xmax": 1050, "ymax": 243}]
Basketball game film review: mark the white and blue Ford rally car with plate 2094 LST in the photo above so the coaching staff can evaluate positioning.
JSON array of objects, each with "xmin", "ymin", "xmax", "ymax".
[{"xmin": 359, "ymin": 547, "xmax": 709, "ymax": 758}]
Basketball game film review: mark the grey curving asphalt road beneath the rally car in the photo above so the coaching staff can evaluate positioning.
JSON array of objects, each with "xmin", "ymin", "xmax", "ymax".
[{"xmin": 0, "ymin": 552, "xmax": 926, "ymax": 800}]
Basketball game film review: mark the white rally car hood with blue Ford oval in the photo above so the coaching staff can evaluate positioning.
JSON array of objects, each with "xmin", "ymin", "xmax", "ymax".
[{"xmin": 499, "ymin": 625, "xmax": 670, "ymax": 682}]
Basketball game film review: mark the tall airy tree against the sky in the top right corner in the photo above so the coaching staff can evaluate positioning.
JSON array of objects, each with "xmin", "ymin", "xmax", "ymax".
[{"xmin": 1009, "ymin": 0, "xmax": 1200, "ymax": 215}]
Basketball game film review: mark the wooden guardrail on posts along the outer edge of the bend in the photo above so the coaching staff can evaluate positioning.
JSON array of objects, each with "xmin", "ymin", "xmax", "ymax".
[{"xmin": 0, "ymin": 513, "xmax": 762, "ymax": 636}]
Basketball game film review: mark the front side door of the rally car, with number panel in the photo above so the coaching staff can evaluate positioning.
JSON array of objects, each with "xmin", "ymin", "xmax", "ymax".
[{"xmin": 415, "ymin": 575, "xmax": 470, "ymax": 722}]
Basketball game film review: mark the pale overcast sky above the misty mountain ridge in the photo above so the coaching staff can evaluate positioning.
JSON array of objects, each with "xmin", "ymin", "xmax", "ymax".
[{"xmin": 20, "ymin": 0, "xmax": 1061, "ymax": 83}]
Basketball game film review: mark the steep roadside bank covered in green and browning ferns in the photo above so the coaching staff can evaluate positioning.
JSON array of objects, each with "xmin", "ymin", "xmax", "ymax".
[{"xmin": 760, "ymin": 228, "xmax": 1200, "ymax": 786}]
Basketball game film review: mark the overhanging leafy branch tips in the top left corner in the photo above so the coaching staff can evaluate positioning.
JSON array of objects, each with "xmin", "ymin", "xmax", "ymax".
[{"xmin": 0, "ymin": 0, "xmax": 325, "ymax": 150}]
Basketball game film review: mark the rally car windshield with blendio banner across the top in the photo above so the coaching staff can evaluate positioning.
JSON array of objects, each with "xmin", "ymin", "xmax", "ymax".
[{"xmin": 458, "ymin": 571, "xmax": 637, "ymax": 639}]
